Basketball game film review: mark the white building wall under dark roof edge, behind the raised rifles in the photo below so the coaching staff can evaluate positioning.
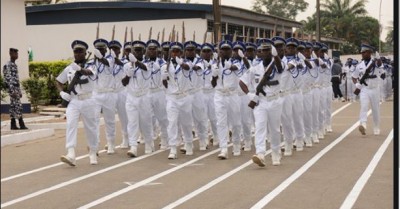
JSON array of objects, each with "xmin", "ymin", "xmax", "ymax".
[{"xmin": 27, "ymin": 18, "xmax": 207, "ymax": 61}]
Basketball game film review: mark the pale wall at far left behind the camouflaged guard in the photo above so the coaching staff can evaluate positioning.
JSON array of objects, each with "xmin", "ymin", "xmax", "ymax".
[{"xmin": 1, "ymin": 0, "xmax": 29, "ymax": 103}]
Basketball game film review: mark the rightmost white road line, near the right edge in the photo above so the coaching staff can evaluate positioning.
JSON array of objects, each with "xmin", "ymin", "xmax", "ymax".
[{"xmin": 340, "ymin": 129, "xmax": 393, "ymax": 209}]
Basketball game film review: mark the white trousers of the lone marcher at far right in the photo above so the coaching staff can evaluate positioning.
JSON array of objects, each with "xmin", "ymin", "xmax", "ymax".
[{"xmin": 360, "ymin": 87, "xmax": 380, "ymax": 128}]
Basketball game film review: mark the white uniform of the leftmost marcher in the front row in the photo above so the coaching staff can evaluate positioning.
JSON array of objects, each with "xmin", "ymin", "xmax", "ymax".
[{"xmin": 56, "ymin": 61, "xmax": 99, "ymax": 151}]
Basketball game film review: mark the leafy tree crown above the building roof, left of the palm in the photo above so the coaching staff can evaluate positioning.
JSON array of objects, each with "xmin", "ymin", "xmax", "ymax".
[{"xmin": 252, "ymin": 0, "xmax": 308, "ymax": 20}]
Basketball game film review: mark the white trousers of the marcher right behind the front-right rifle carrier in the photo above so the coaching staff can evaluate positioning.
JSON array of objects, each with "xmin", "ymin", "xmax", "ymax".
[{"xmin": 281, "ymin": 94, "xmax": 294, "ymax": 142}]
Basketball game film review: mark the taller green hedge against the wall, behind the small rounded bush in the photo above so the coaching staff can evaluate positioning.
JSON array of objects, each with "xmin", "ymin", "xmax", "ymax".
[{"xmin": 24, "ymin": 60, "xmax": 72, "ymax": 105}]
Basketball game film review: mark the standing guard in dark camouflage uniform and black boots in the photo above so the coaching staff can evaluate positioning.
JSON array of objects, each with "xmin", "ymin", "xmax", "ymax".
[{"xmin": 3, "ymin": 48, "xmax": 28, "ymax": 130}]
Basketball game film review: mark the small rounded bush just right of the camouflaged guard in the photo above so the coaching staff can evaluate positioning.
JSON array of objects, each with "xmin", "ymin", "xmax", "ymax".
[{"xmin": 21, "ymin": 78, "xmax": 46, "ymax": 112}]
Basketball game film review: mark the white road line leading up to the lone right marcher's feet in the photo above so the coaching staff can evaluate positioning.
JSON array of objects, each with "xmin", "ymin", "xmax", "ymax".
[{"xmin": 251, "ymin": 110, "xmax": 372, "ymax": 209}]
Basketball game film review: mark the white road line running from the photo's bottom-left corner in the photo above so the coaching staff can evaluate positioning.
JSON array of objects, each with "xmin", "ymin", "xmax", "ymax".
[{"xmin": 1, "ymin": 150, "xmax": 165, "ymax": 208}]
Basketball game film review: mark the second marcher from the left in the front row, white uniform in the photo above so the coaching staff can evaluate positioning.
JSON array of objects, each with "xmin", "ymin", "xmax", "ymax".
[{"xmin": 124, "ymin": 41, "xmax": 154, "ymax": 157}]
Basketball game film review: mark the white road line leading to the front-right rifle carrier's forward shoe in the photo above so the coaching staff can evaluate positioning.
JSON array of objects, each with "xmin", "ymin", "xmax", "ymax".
[{"xmin": 163, "ymin": 103, "xmax": 351, "ymax": 209}]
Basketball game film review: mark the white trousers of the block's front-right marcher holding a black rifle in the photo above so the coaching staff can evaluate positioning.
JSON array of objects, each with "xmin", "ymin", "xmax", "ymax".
[{"xmin": 253, "ymin": 97, "xmax": 283, "ymax": 154}]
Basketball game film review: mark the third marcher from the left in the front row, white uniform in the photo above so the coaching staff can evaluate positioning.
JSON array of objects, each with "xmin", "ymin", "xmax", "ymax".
[{"xmin": 161, "ymin": 42, "xmax": 193, "ymax": 159}]
